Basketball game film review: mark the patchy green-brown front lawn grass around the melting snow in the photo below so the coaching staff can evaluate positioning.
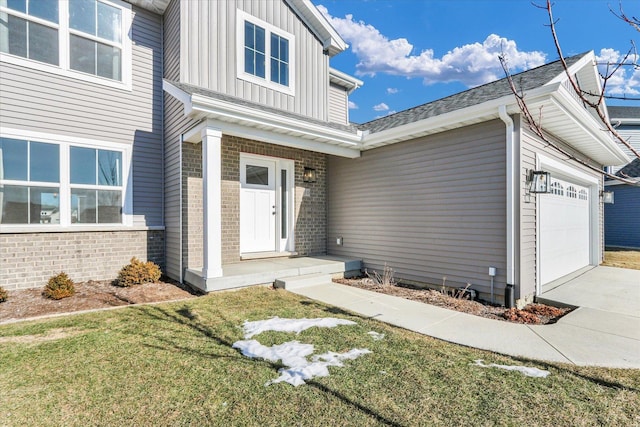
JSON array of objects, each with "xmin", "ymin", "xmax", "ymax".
[{"xmin": 0, "ymin": 287, "xmax": 640, "ymax": 426}]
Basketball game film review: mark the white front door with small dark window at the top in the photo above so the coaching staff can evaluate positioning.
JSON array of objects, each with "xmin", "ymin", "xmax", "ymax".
[{"xmin": 240, "ymin": 157, "xmax": 277, "ymax": 253}]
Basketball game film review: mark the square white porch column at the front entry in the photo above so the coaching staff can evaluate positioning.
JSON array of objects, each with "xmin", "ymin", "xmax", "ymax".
[{"xmin": 202, "ymin": 127, "xmax": 222, "ymax": 280}]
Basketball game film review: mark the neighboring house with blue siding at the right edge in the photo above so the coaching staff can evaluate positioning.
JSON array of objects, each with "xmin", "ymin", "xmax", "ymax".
[{"xmin": 604, "ymin": 107, "xmax": 640, "ymax": 249}]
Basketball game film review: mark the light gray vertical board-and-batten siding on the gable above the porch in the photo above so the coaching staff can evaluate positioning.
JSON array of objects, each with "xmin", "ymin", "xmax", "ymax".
[{"xmin": 180, "ymin": 0, "xmax": 329, "ymax": 120}]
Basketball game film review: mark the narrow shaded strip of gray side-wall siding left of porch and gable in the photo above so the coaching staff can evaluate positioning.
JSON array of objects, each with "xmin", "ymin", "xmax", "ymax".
[{"xmin": 164, "ymin": 0, "xmax": 198, "ymax": 280}]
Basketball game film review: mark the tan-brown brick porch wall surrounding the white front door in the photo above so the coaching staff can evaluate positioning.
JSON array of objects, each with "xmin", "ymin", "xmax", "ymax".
[{"xmin": 182, "ymin": 135, "xmax": 327, "ymax": 268}]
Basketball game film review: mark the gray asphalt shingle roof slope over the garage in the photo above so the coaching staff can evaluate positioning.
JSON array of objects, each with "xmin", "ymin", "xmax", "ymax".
[{"xmin": 358, "ymin": 53, "xmax": 586, "ymax": 133}]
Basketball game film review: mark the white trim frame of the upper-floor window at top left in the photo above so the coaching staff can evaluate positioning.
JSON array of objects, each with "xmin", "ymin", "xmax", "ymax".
[{"xmin": 0, "ymin": 0, "xmax": 133, "ymax": 91}]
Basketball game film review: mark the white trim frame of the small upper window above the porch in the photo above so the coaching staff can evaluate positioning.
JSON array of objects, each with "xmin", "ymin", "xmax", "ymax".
[{"xmin": 236, "ymin": 9, "xmax": 296, "ymax": 96}]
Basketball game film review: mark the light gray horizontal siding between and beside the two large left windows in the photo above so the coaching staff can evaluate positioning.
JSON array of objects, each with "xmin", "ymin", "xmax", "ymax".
[{"xmin": 0, "ymin": 7, "xmax": 163, "ymax": 226}]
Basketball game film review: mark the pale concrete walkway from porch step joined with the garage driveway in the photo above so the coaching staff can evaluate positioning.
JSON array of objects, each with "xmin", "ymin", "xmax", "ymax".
[{"xmin": 291, "ymin": 267, "xmax": 640, "ymax": 369}]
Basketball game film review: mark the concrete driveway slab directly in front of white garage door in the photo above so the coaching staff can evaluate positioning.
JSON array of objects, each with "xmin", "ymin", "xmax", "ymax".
[{"xmin": 540, "ymin": 266, "xmax": 640, "ymax": 317}]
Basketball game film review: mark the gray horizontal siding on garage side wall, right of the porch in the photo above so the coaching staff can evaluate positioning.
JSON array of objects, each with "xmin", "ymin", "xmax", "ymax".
[{"xmin": 327, "ymin": 120, "xmax": 506, "ymax": 297}]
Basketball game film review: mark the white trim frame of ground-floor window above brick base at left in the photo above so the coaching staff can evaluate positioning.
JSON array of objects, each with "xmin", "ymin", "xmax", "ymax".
[{"xmin": 0, "ymin": 127, "xmax": 133, "ymax": 233}]
